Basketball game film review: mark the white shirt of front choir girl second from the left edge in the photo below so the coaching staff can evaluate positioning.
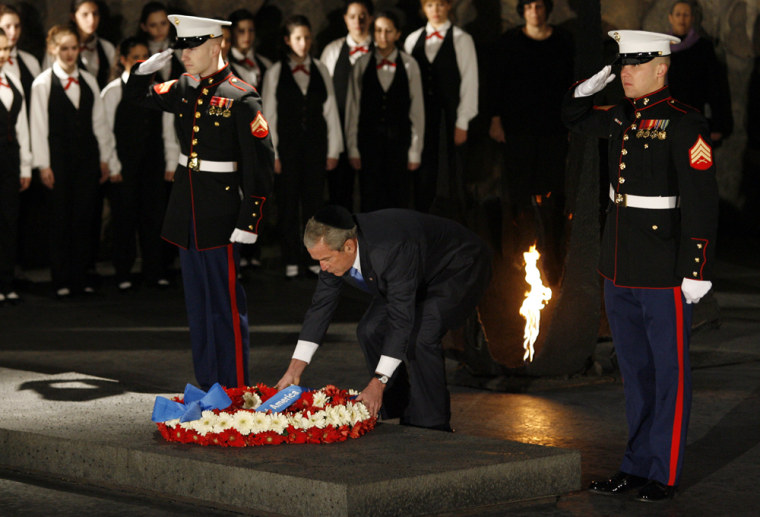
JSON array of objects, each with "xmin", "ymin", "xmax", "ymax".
[{"xmin": 30, "ymin": 62, "xmax": 121, "ymax": 172}]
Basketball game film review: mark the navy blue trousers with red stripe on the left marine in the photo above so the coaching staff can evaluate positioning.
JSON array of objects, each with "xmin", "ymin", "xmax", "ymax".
[{"xmin": 179, "ymin": 238, "xmax": 249, "ymax": 390}]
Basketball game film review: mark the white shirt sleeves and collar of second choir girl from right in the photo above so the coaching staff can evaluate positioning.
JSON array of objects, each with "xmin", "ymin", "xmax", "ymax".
[{"xmin": 345, "ymin": 49, "xmax": 425, "ymax": 163}]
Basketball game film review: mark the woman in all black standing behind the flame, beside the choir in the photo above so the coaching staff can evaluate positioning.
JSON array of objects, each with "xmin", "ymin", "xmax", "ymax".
[{"xmin": 488, "ymin": 0, "xmax": 574, "ymax": 280}]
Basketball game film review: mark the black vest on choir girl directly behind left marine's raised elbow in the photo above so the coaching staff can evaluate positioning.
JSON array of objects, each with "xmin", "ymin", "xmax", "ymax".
[{"xmin": 113, "ymin": 81, "xmax": 164, "ymax": 171}]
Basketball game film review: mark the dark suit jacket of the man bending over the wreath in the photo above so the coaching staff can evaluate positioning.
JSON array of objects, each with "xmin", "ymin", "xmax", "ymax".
[{"xmin": 300, "ymin": 209, "xmax": 491, "ymax": 359}]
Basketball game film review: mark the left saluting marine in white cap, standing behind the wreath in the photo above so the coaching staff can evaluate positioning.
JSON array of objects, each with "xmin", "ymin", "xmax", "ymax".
[{"xmin": 124, "ymin": 14, "xmax": 273, "ymax": 389}]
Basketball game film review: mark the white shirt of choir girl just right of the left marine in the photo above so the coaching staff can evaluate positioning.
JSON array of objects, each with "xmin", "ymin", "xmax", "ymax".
[{"xmin": 261, "ymin": 56, "xmax": 343, "ymax": 160}]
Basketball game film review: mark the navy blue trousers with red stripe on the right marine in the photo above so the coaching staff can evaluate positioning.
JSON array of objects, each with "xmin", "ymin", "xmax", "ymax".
[{"xmin": 604, "ymin": 280, "xmax": 692, "ymax": 486}]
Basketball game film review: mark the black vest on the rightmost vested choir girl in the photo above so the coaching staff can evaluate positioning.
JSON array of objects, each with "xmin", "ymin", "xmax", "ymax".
[{"xmin": 412, "ymin": 25, "xmax": 462, "ymax": 124}]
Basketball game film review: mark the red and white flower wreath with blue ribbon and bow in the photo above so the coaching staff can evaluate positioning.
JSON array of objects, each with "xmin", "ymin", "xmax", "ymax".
[{"xmin": 152, "ymin": 383, "xmax": 377, "ymax": 447}]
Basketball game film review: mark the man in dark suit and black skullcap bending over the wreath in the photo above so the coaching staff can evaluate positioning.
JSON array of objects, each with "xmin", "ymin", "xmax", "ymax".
[{"xmin": 277, "ymin": 206, "xmax": 491, "ymax": 431}]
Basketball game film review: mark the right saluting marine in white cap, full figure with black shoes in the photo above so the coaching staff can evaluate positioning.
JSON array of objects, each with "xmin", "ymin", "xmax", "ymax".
[{"xmin": 563, "ymin": 30, "xmax": 718, "ymax": 501}]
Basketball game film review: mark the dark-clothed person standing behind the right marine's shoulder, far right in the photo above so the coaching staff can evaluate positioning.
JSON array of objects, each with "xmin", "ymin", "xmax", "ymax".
[{"xmin": 668, "ymin": 1, "xmax": 734, "ymax": 147}]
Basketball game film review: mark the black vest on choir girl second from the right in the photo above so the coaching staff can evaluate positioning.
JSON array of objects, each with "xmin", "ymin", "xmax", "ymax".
[{"xmin": 359, "ymin": 51, "xmax": 412, "ymax": 148}]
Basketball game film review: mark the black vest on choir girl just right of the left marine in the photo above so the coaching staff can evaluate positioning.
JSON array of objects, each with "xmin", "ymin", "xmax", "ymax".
[{"xmin": 277, "ymin": 60, "xmax": 327, "ymax": 152}]
